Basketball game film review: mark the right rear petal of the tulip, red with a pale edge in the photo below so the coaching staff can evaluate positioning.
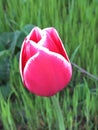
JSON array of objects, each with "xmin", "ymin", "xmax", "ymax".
[{"xmin": 43, "ymin": 27, "xmax": 69, "ymax": 61}]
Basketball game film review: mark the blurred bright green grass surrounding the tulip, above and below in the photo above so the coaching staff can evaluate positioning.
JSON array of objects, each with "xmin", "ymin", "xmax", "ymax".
[{"xmin": 0, "ymin": 0, "xmax": 98, "ymax": 130}]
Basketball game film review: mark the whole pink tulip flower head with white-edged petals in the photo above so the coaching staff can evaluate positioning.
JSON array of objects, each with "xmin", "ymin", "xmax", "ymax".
[{"xmin": 20, "ymin": 27, "xmax": 72, "ymax": 96}]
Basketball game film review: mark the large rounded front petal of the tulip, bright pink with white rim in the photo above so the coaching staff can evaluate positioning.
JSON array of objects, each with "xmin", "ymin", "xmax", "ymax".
[{"xmin": 23, "ymin": 45, "xmax": 72, "ymax": 96}]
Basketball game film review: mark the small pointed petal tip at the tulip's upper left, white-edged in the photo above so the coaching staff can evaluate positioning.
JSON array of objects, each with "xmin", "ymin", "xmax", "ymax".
[{"xmin": 27, "ymin": 27, "xmax": 42, "ymax": 43}]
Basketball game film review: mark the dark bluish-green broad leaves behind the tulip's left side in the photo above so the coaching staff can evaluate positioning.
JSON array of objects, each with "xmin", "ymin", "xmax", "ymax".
[{"xmin": 0, "ymin": 24, "xmax": 34, "ymax": 96}]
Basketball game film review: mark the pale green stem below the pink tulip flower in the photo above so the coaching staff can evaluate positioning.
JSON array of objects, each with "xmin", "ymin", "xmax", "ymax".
[{"xmin": 51, "ymin": 96, "xmax": 65, "ymax": 130}]
